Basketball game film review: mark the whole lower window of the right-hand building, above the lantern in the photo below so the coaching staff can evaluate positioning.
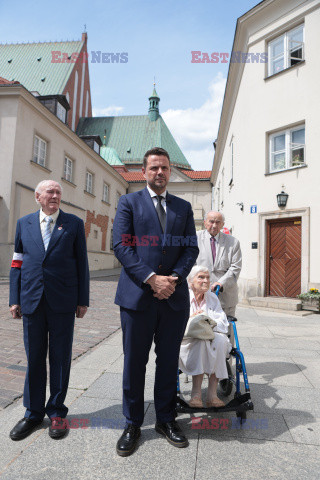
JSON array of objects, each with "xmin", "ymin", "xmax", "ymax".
[{"xmin": 269, "ymin": 126, "xmax": 305, "ymax": 173}]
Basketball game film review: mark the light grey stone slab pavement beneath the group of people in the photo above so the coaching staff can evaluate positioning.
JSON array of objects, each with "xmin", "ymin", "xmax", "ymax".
[{"xmin": 0, "ymin": 300, "xmax": 320, "ymax": 480}]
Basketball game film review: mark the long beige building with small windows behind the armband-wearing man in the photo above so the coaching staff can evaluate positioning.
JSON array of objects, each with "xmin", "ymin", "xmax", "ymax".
[{"xmin": 0, "ymin": 79, "xmax": 128, "ymax": 275}]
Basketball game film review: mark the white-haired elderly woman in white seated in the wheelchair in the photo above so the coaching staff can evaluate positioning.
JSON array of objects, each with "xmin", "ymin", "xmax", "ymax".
[{"xmin": 179, "ymin": 266, "xmax": 231, "ymax": 408}]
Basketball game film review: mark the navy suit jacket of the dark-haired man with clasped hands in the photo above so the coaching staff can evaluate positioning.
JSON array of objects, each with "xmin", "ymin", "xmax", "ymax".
[{"xmin": 113, "ymin": 188, "xmax": 199, "ymax": 311}]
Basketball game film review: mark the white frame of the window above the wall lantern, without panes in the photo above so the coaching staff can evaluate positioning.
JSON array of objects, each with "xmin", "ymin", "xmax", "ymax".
[{"xmin": 268, "ymin": 123, "xmax": 307, "ymax": 173}]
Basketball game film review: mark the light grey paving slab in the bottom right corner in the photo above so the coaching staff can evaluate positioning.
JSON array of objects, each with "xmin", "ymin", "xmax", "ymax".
[{"xmin": 194, "ymin": 434, "xmax": 320, "ymax": 480}]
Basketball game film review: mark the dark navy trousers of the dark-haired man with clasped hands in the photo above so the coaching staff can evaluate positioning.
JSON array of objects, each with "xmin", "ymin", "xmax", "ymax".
[{"xmin": 120, "ymin": 298, "xmax": 190, "ymax": 426}]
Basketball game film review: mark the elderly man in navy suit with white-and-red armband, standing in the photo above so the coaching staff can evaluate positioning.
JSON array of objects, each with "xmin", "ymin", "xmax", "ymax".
[{"xmin": 10, "ymin": 180, "xmax": 89, "ymax": 440}]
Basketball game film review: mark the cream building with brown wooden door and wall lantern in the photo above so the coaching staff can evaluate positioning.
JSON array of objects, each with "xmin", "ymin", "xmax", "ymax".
[{"xmin": 211, "ymin": 0, "xmax": 320, "ymax": 299}]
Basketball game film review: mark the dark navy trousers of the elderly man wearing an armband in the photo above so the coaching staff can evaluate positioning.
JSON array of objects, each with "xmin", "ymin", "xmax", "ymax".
[{"xmin": 23, "ymin": 295, "xmax": 74, "ymax": 419}]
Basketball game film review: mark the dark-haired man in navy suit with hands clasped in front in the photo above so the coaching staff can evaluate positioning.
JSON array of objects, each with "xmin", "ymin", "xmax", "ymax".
[{"xmin": 113, "ymin": 148, "xmax": 199, "ymax": 456}]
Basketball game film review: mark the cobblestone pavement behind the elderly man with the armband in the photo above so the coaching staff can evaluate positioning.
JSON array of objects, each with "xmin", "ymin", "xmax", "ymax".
[{"xmin": 0, "ymin": 276, "xmax": 120, "ymax": 410}]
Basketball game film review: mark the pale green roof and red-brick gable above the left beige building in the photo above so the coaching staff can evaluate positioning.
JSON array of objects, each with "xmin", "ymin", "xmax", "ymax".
[{"xmin": 0, "ymin": 33, "xmax": 92, "ymax": 131}]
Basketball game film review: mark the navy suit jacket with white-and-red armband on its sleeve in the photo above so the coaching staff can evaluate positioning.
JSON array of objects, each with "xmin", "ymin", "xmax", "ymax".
[{"xmin": 9, "ymin": 210, "xmax": 89, "ymax": 314}]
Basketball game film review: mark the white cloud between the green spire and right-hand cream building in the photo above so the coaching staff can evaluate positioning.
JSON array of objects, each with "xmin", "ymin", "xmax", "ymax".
[{"xmin": 161, "ymin": 73, "xmax": 226, "ymax": 170}]
